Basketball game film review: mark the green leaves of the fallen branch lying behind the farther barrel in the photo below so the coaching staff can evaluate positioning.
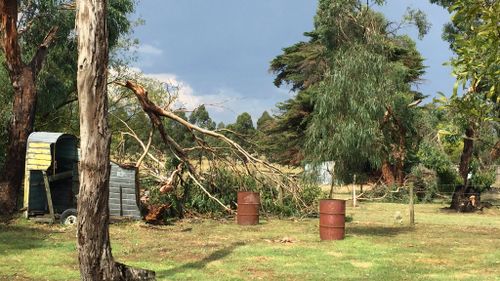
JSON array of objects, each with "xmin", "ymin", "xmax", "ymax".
[{"xmin": 143, "ymin": 167, "xmax": 321, "ymax": 216}]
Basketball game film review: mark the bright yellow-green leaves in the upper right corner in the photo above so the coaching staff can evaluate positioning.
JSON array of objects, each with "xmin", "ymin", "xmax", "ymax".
[{"xmin": 431, "ymin": 0, "xmax": 500, "ymax": 100}]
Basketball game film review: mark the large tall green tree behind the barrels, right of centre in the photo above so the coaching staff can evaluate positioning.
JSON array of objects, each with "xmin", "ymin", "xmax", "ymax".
[{"xmin": 271, "ymin": 0, "xmax": 428, "ymax": 183}]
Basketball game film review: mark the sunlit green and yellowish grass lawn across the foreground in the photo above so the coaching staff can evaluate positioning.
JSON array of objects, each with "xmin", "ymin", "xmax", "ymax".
[{"xmin": 0, "ymin": 203, "xmax": 500, "ymax": 281}]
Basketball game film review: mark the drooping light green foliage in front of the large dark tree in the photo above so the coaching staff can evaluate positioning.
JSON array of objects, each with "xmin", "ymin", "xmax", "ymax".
[{"xmin": 306, "ymin": 43, "xmax": 406, "ymax": 179}]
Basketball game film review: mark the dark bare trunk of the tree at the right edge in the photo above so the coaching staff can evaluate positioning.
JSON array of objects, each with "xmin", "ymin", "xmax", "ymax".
[{"xmin": 450, "ymin": 125, "xmax": 475, "ymax": 209}]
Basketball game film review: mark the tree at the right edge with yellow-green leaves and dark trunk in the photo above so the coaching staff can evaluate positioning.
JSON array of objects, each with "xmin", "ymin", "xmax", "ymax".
[{"xmin": 431, "ymin": 0, "xmax": 500, "ymax": 208}]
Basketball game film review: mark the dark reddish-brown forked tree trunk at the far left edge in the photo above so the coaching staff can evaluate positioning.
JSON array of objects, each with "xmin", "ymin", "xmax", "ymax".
[{"xmin": 0, "ymin": 0, "xmax": 57, "ymax": 214}]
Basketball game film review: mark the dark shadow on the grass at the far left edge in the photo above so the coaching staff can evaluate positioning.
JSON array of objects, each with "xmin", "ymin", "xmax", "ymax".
[{"xmin": 0, "ymin": 223, "xmax": 53, "ymax": 255}]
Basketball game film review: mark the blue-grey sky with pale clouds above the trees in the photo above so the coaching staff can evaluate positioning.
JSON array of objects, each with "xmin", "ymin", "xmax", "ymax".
[{"xmin": 134, "ymin": 0, "xmax": 454, "ymax": 124}]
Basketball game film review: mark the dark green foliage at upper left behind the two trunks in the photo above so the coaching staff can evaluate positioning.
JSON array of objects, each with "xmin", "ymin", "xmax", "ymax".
[{"xmin": 0, "ymin": 0, "xmax": 136, "ymax": 142}]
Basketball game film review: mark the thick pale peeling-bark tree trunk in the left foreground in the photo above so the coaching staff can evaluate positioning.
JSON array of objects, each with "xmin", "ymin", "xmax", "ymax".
[{"xmin": 76, "ymin": 0, "xmax": 154, "ymax": 280}]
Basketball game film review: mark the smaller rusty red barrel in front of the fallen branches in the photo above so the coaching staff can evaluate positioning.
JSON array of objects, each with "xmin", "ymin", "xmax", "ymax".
[{"xmin": 236, "ymin": 191, "xmax": 260, "ymax": 225}]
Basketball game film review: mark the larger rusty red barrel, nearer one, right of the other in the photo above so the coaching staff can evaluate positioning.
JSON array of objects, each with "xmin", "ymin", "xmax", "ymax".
[{"xmin": 319, "ymin": 199, "xmax": 345, "ymax": 240}]
